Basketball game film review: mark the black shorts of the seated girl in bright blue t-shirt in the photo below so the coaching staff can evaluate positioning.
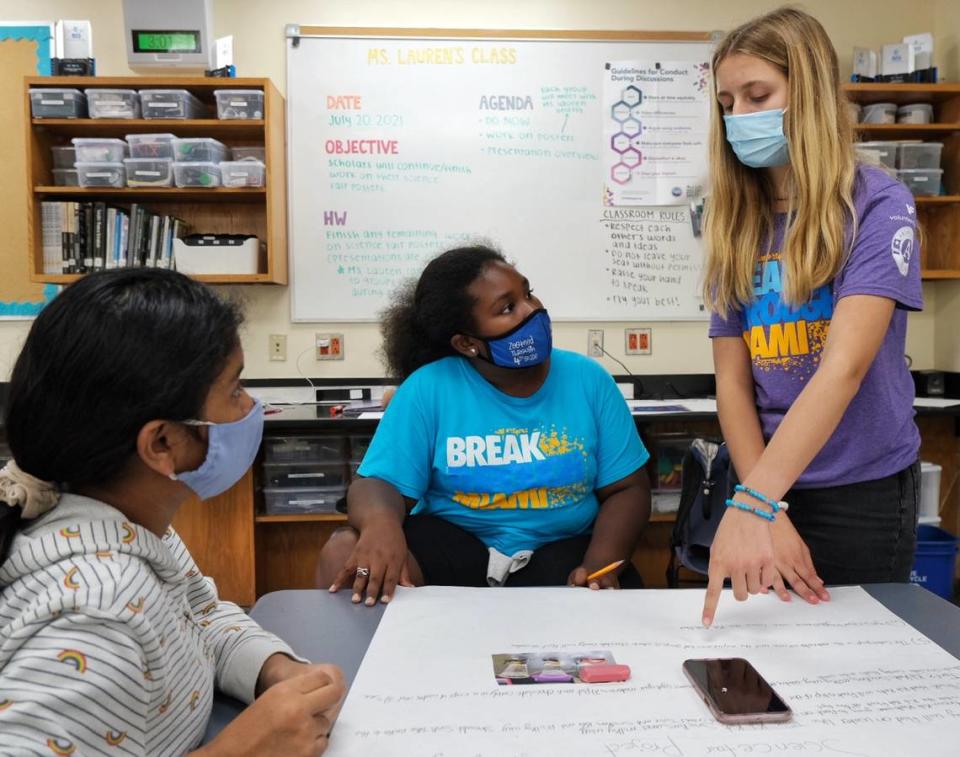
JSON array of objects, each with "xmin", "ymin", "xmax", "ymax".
[{"xmin": 403, "ymin": 515, "xmax": 643, "ymax": 589}]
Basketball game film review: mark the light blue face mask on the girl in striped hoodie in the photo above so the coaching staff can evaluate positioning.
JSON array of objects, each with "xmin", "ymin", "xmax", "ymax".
[{"xmin": 171, "ymin": 402, "xmax": 263, "ymax": 499}]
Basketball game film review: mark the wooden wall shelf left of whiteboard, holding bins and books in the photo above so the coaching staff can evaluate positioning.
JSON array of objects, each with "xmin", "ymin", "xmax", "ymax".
[{"xmin": 23, "ymin": 76, "xmax": 288, "ymax": 284}]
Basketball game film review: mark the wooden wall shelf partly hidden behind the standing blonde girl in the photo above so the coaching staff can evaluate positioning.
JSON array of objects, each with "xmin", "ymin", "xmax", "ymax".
[{"xmin": 844, "ymin": 84, "xmax": 960, "ymax": 281}]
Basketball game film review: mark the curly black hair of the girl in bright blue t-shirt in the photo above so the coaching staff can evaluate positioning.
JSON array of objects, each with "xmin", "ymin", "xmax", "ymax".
[{"xmin": 380, "ymin": 245, "xmax": 507, "ymax": 381}]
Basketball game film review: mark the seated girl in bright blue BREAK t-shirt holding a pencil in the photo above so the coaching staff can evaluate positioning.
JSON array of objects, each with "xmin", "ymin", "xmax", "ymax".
[{"xmin": 317, "ymin": 247, "xmax": 650, "ymax": 605}]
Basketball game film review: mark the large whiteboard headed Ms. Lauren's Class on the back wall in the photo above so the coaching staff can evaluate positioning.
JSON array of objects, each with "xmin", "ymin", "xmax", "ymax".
[{"xmin": 287, "ymin": 27, "xmax": 712, "ymax": 321}]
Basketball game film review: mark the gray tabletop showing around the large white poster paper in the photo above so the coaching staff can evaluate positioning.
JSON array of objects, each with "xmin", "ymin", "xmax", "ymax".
[{"xmin": 205, "ymin": 584, "xmax": 960, "ymax": 741}]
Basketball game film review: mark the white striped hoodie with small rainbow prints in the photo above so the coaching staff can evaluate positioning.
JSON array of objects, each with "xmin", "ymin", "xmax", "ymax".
[{"xmin": 0, "ymin": 494, "xmax": 293, "ymax": 757}]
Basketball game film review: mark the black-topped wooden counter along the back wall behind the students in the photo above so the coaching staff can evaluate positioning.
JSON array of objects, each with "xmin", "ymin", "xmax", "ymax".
[{"xmin": 175, "ymin": 374, "xmax": 960, "ymax": 606}]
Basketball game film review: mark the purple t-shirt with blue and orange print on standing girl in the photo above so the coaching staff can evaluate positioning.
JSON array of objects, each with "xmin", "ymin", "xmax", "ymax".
[{"xmin": 709, "ymin": 166, "xmax": 923, "ymax": 488}]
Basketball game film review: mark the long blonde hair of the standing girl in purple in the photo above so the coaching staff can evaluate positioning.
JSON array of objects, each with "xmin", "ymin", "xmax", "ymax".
[{"xmin": 703, "ymin": 8, "xmax": 856, "ymax": 314}]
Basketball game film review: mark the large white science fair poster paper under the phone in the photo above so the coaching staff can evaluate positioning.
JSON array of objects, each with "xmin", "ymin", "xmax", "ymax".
[{"xmin": 327, "ymin": 587, "xmax": 960, "ymax": 757}]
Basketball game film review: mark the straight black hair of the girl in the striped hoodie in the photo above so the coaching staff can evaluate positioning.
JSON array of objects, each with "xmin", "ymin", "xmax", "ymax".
[{"xmin": 5, "ymin": 268, "xmax": 243, "ymax": 486}]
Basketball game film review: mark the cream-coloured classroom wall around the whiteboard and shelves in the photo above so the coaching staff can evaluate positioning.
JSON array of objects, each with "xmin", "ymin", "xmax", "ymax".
[{"xmin": 0, "ymin": 0, "xmax": 944, "ymax": 380}]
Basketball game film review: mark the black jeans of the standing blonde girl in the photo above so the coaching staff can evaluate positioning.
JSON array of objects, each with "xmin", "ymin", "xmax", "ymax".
[{"xmin": 784, "ymin": 461, "xmax": 920, "ymax": 585}]
